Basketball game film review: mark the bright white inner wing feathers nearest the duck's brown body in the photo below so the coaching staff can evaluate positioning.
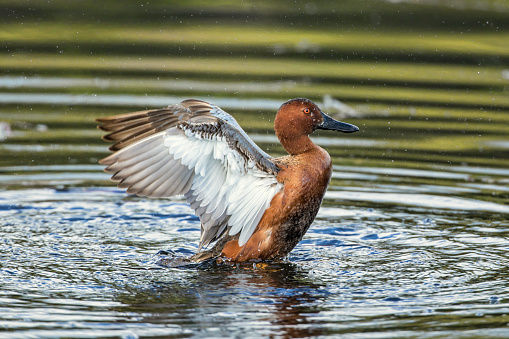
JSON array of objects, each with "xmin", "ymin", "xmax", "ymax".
[{"xmin": 164, "ymin": 130, "xmax": 281, "ymax": 246}]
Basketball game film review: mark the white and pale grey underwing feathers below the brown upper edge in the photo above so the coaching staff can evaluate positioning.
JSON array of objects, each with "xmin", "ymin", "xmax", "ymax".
[{"xmin": 103, "ymin": 119, "xmax": 282, "ymax": 248}]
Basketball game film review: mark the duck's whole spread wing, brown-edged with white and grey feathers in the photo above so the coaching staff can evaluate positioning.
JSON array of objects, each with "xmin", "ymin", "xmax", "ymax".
[{"xmin": 97, "ymin": 99, "xmax": 282, "ymax": 249}]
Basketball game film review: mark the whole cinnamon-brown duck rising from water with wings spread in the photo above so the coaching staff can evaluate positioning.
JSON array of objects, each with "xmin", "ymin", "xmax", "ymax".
[{"xmin": 96, "ymin": 98, "xmax": 359, "ymax": 262}]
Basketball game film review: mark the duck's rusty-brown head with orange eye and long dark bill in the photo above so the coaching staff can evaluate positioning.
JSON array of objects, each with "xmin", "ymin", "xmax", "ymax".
[{"xmin": 274, "ymin": 98, "xmax": 359, "ymax": 154}]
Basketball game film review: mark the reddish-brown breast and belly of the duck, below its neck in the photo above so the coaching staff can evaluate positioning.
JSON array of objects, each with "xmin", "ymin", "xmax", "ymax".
[{"xmin": 223, "ymin": 147, "xmax": 332, "ymax": 261}]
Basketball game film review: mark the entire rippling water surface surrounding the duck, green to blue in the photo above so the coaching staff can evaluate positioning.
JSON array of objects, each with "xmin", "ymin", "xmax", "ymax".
[{"xmin": 0, "ymin": 1, "xmax": 509, "ymax": 338}]
